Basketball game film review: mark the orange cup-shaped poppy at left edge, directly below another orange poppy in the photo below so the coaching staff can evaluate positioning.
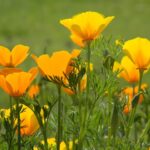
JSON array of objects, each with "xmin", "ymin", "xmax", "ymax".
[{"xmin": 0, "ymin": 68, "xmax": 37, "ymax": 97}]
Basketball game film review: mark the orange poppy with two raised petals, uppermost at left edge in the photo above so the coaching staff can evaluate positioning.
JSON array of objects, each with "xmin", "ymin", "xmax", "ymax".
[{"xmin": 0, "ymin": 45, "xmax": 29, "ymax": 67}]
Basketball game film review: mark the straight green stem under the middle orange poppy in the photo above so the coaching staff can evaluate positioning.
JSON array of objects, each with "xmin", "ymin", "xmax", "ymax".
[{"xmin": 57, "ymin": 85, "xmax": 63, "ymax": 150}]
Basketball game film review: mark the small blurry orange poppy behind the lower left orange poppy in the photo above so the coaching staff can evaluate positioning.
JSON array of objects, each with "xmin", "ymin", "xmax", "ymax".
[{"xmin": 28, "ymin": 85, "xmax": 40, "ymax": 99}]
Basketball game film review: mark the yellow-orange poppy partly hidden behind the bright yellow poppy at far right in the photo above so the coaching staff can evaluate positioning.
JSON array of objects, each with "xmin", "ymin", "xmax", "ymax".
[{"xmin": 113, "ymin": 56, "xmax": 139, "ymax": 83}]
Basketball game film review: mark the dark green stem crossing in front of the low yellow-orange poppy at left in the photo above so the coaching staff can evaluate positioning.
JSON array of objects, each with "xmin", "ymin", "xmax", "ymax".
[{"xmin": 16, "ymin": 99, "xmax": 21, "ymax": 150}]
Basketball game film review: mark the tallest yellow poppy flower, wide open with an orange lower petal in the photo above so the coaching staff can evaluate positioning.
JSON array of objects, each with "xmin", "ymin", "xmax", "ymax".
[{"xmin": 60, "ymin": 11, "xmax": 114, "ymax": 47}]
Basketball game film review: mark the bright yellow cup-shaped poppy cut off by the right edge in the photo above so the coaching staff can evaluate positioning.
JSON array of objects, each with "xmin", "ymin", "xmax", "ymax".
[{"xmin": 123, "ymin": 37, "xmax": 150, "ymax": 69}]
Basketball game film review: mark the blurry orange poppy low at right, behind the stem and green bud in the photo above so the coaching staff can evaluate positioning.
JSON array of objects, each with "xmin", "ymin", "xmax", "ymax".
[{"xmin": 123, "ymin": 84, "xmax": 148, "ymax": 114}]
